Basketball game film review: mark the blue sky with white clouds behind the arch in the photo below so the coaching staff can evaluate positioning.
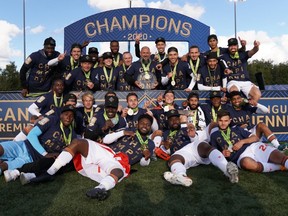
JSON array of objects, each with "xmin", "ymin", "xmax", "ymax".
[{"xmin": 0, "ymin": 0, "xmax": 288, "ymax": 70}]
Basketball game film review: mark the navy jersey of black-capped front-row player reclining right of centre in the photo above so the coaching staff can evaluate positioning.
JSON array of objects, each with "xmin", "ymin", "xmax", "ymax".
[{"xmin": 163, "ymin": 127, "xmax": 191, "ymax": 155}]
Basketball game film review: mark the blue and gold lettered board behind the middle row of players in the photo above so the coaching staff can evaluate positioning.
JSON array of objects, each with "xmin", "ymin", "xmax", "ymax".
[{"xmin": 0, "ymin": 90, "xmax": 288, "ymax": 141}]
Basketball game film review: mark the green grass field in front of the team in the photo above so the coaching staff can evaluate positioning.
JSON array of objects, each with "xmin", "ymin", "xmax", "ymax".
[{"xmin": 0, "ymin": 159, "xmax": 288, "ymax": 216}]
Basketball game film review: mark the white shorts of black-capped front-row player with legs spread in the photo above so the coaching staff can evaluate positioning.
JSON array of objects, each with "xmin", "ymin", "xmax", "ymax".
[{"xmin": 173, "ymin": 141, "xmax": 211, "ymax": 169}]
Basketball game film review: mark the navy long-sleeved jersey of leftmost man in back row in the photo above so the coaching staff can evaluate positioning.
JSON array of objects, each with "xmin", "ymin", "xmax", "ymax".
[{"xmin": 20, "ymin": 49, "xmax": 60, "ymax": 92}]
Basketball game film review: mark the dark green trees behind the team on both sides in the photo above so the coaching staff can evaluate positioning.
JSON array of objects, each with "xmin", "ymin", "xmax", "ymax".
[{"xmin": 0, "ymin": 60, "xmax": 288, "ymax": 91}]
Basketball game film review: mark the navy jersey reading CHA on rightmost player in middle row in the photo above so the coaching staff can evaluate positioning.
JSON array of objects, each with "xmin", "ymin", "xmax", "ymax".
[{"xmin": 227, "ymin": 104, "xmax": 257, "ymax": 130}]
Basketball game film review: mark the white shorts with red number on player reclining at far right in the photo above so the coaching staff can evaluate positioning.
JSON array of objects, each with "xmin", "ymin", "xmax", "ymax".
[{"xmin": 237, "ymin": 142, "xmax": 276, "ymax": 168}]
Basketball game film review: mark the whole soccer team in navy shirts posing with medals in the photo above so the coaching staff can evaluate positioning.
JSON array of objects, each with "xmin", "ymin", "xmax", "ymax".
[{"xmin": 0, "ymin": 35, "xmax": 288, "ymax": 200}]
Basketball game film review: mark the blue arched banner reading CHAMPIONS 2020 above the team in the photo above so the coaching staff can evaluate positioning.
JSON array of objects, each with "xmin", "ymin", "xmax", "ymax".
[{"xmin": 64, "ymin": 8, "xmax": 210, "ymax": 52}]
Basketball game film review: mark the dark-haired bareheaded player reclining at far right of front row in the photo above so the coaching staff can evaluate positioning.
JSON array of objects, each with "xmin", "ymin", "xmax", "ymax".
[{"xmin": 210, "ymin": 110, "xmax": 288, "ymax": 172}]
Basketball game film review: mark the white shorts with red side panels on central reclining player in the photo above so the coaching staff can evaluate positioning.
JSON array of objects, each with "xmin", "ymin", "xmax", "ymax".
[{"xmin": 73, "ymin": 140, "xmax": 128, "ymax": 183}]
